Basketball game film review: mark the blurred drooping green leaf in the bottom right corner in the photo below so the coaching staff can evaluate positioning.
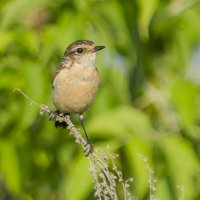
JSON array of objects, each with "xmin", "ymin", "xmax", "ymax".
[{"xmin": 159, "ymin": 135, "xmax": 200, "ymax": 199}]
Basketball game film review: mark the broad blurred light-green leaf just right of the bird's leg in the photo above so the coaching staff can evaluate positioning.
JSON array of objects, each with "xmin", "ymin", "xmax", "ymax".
[{"xmin": 87, "ymin": 106, "xmax": 153, "ymax": 141}]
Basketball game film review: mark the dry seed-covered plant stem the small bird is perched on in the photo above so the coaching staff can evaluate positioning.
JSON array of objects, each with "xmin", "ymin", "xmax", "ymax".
[{"xmin": 15, "ymin": 89, "xmax": 133, "ymax": 200}]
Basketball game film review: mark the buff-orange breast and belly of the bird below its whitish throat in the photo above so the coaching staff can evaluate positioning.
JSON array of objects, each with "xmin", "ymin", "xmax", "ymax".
[{"xmin": 53, "ymin": 67, "xmax": 100, "ymax": 113}]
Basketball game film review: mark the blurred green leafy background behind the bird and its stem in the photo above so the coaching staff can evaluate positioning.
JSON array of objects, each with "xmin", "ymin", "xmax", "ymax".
[{"xmin": 0, "ymin": 0, "xmax": 200, "ymax": 200}]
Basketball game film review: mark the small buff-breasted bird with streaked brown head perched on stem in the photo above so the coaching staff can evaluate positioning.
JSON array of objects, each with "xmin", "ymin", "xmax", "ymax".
[{"xmin": 51, "ymin": 40, "xmax": 105, "ymax": 156}]
